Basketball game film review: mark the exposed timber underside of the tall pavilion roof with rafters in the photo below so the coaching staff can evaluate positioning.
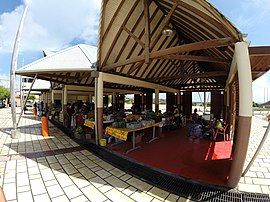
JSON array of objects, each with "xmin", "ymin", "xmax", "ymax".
[{"xmin": 98, "ymin": 0, "xmax": 269, "ymax": 90}]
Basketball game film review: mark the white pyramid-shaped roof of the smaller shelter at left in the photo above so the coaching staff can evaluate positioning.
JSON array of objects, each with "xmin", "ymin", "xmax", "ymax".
[{"xmin": 16, "ymin": 44, "xmax": 97, "ymax": 85}]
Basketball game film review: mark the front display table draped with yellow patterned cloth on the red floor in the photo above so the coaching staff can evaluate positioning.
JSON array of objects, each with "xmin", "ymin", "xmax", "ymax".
[{"xmin": 105, "ymin": 123, "xmax": 162, "ymax": 154}]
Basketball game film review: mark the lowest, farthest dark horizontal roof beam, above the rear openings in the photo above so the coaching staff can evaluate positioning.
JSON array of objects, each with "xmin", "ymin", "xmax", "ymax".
[{"xmin": 151, "ymin": 71, "xmax": 228, "ymax": 81}]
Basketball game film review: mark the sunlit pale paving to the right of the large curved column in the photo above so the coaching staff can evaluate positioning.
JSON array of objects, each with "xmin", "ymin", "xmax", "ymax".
[{"xmin": 238, "ymin": 117, "xmax": 270, "ymax": 194}]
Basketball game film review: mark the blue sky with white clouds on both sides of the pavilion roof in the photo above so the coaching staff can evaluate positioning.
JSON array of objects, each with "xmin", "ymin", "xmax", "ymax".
[{"xmin": 0, "ymin": 0, "xmax": 270, "ymax": 102}]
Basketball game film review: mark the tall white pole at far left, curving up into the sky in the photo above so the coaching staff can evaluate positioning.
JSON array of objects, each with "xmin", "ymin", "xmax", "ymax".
[{"xmin": 10, "ymin": 4, "xmax": 28, "ymax": 138}]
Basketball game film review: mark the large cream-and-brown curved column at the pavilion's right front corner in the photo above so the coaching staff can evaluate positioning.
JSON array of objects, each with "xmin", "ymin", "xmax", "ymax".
[{"xmin": 228, "ymin": 42, "xmax": 252, "ymax": 187}]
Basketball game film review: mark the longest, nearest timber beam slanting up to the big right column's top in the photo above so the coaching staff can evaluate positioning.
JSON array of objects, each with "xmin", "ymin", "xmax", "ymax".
[{"xmin": 102, "ymin": 37, "xmax": 234, "ymax": 71}]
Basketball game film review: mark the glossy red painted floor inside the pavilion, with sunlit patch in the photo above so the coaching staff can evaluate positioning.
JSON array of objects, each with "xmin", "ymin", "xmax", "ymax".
[{"xmin": 109, "ymin": 129, "xmax": 232, "ymax": 185}]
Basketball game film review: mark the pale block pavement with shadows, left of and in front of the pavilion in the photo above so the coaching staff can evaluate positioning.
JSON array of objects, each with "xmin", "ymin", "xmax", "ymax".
[{"xmin": 0, "ymin": 108, "xmax": 186, "ymax": 202}]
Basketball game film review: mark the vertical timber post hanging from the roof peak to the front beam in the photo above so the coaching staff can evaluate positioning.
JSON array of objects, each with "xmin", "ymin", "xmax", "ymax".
[{"xmin": 143, "ymin": 0, "xmax": 151, "ymax": 64}]
